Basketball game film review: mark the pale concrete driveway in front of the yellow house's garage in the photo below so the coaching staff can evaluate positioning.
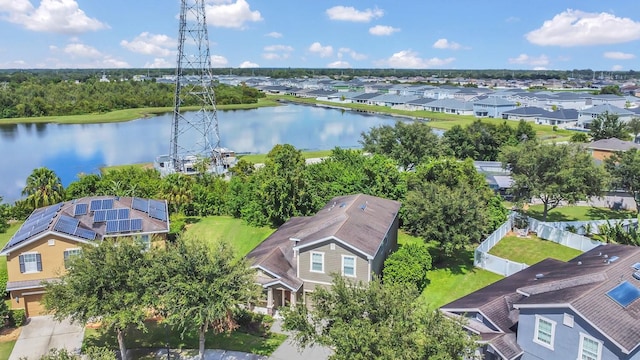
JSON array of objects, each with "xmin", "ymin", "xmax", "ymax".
[{"xmin": 9, "ymin": 316, "xmax": 84, "ymax": 360}]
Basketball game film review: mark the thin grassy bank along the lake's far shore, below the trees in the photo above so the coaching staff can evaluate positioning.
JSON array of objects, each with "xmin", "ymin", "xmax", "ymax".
[{"xmin": 0, "ymin": 99, "xmax": 278, "ymax": 124}]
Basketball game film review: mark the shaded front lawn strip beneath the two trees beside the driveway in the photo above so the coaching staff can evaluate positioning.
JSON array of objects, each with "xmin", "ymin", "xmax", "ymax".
[{"xmin": 83, "ymin": 321, "xmax": 287, "ymax": 356}]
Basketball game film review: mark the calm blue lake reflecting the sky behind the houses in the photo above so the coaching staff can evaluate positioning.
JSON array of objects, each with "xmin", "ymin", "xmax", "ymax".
[{"xmin": 0, "ymin": 105, "xmax": 436, "ymax": 203}]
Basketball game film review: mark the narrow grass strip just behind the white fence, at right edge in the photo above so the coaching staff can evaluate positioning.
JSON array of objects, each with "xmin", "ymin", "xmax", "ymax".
[{"xmin": 525, "ymin": 204, "xmax": 636, "ymax": 222}]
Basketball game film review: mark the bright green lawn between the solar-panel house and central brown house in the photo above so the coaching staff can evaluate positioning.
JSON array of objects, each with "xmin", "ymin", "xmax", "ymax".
[{"xmin": 184, "ymin": 216, "xmax": 274, "ymax": 256}]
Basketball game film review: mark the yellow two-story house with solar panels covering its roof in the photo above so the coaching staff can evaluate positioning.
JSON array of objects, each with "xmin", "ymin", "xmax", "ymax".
[{"xmin": 0, "ymin": 196, "xmax": 169, "ymax": 317}]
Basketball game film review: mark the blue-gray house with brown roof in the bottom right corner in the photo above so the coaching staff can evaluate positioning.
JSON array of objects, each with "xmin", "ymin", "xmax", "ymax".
[{"xmin": 441, "ymin": 244, "xmax": 640, "ymax": 360}]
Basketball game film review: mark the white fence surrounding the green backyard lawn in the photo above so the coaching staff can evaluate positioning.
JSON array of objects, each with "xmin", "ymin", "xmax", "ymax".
[{"xmin": 473, "ymin": 212, "xmax": 612, "ymax": 276}]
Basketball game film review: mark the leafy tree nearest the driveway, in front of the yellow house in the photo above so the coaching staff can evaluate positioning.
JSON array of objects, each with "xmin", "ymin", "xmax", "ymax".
[{"xmin": 43, "ymin": 239, "xmax": 151, "ymax": 359}]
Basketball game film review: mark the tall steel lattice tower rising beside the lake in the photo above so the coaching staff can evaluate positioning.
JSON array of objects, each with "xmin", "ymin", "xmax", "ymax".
[{"xmin": 167, "ymin": 0, "xmax": 222, "ymax": 173}]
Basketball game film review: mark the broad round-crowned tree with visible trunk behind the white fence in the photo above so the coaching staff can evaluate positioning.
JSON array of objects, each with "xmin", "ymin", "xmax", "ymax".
[{"xmin": 501, "ymin": 142, "xmax": 607, "ymax": 221}]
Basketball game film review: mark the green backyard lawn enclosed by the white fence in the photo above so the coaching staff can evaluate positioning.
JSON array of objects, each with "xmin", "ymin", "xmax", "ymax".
[{"xmin": 489, "ymin": 236, "xmax": 582, "ymax": 265}]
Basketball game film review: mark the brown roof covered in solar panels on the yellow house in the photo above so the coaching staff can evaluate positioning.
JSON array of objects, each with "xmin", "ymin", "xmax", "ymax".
[{"xmin": 0, "ymin": 196, "xmax": 169, "ymax": 255}]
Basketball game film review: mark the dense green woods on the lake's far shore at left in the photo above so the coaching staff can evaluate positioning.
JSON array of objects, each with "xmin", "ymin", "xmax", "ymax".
[{"xmin": 0, "ymin": 74, "xmax": 264, "ymax": 119}]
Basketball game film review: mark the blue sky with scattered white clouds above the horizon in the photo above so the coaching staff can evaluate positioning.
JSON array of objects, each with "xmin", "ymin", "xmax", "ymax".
[{"xmin": 0, "ymin": 0, "xmax": 640, "ymax": 71}]
